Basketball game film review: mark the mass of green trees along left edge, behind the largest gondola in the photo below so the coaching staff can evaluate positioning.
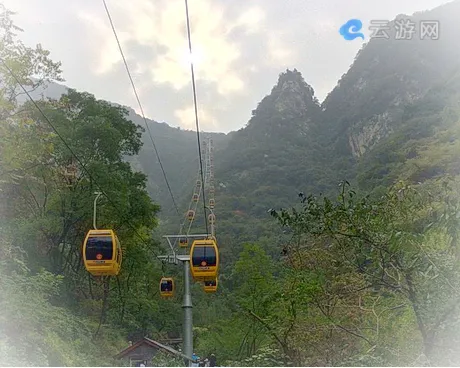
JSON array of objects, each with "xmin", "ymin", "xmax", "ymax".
[{"xmin": 0, "ymin": 5, "xmax": 171, "ymax": 365}]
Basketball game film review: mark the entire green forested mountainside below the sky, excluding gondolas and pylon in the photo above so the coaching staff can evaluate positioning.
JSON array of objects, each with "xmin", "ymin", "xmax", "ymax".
[{"xmin": 0, "ymin": 1, "xmax": 460, "ymax": 366}]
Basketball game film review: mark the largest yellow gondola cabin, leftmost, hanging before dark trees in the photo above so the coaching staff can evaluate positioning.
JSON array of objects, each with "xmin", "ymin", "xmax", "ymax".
[{"xmin": 83, "ymin": 230, "xmax": 123, "ymax": 276}]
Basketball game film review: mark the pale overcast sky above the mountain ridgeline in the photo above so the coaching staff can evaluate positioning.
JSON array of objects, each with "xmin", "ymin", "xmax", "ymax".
[{"xmin": 0, "ymin": 0, "xmax": 450, "ymax": 133}]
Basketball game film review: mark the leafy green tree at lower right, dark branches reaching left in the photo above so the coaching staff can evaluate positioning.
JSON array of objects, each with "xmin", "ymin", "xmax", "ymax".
[{"xmin": 272, "ymin": 182, "xmax": 460, "ymax": 362}]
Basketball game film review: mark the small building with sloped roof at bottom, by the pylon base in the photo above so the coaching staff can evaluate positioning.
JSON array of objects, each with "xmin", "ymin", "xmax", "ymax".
[{"xmin": 115, "ymin": 337, "xmax": 191, "ymax": 367}]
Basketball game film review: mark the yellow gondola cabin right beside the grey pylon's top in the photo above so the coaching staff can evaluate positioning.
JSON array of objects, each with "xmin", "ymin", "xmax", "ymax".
[{"xmin": 190, "ymin": 239, "xmax": 219, "ymax": 281}]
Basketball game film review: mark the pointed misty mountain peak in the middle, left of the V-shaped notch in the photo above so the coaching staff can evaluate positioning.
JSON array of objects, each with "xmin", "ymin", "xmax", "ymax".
[{"xmin": 216, "ymin": 69, "xmax": 327, "ymax": 216}]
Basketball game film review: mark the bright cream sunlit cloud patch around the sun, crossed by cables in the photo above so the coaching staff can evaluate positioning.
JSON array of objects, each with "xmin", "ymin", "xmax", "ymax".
[{"xmin": 79, "ymin": 0, "xmax": 264, "ymax": 95}]
